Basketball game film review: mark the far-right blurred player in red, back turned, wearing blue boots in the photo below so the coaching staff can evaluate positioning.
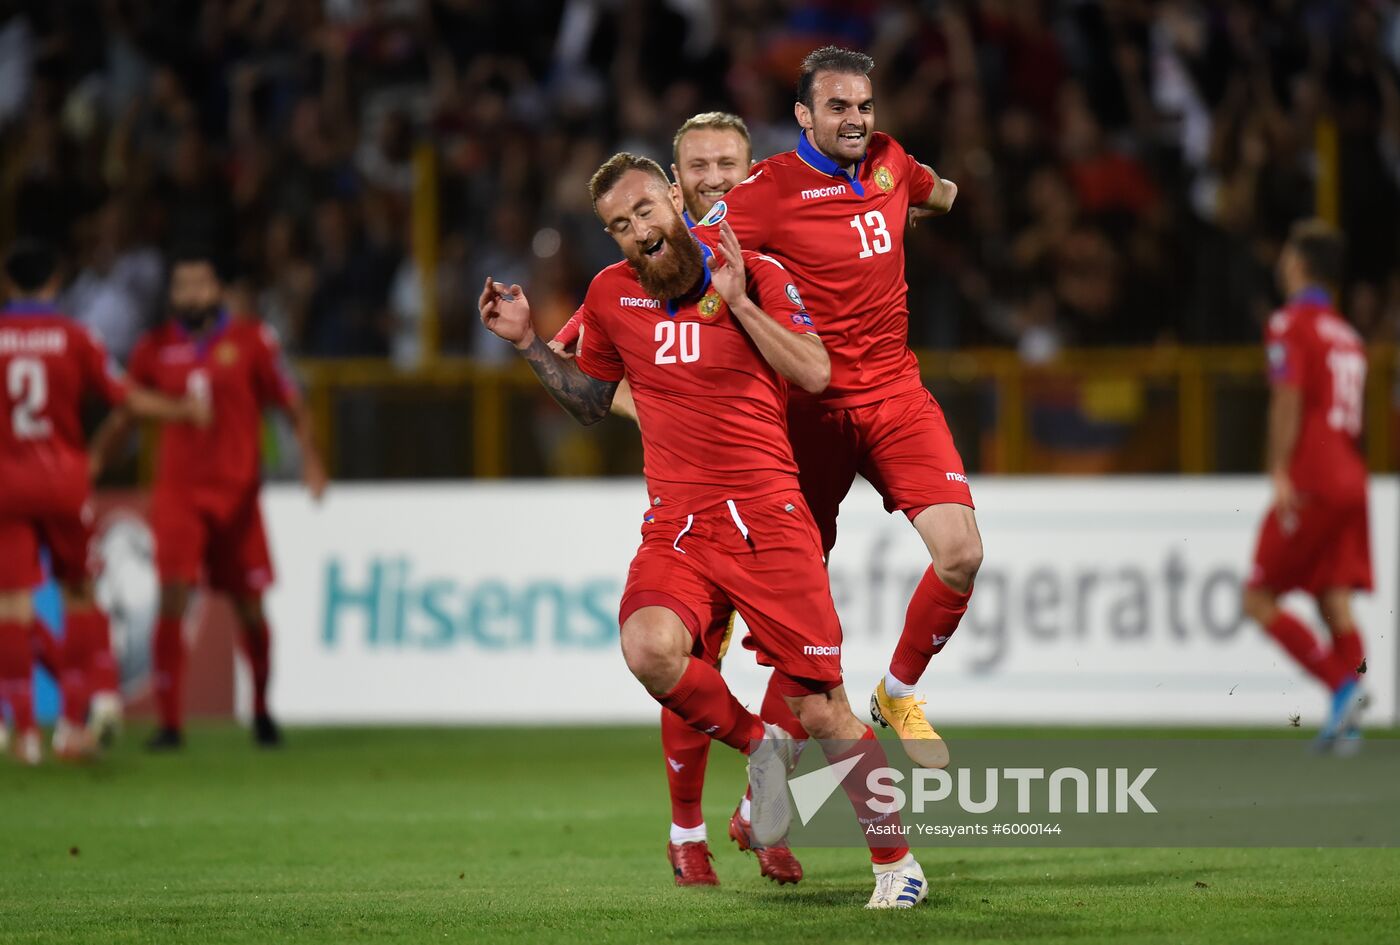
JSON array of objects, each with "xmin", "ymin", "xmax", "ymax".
[{"xmin": 1245, "ymin": 220, "xmax": 1371, "ymax": 753}]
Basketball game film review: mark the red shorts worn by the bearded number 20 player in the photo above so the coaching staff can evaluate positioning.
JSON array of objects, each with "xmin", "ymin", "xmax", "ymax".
[{"xmin": 619, "ymin": 491, "xmax": 841, "ymax": 696}]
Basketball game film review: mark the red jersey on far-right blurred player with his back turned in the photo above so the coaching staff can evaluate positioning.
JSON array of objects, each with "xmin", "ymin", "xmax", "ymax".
[{"xmin": 1266, "ymin": 290, "xmax": 1366, "ymax": 501}]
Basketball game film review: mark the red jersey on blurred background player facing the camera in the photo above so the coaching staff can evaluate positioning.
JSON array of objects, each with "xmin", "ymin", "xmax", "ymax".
[{"xmin": 130, "ymin": 315, "xmax": 297, "ymax": 496}]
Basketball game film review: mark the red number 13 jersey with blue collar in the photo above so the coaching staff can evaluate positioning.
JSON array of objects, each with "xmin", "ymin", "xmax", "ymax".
[{"xmin": 696, "ymin": 132, "xmax": 937, "ymax": 407}]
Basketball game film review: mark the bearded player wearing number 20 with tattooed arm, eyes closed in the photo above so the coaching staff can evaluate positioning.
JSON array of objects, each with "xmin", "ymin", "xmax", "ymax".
[{"xmin": 480, "ymin": 153, "xmax": 927, "ymax": 909}]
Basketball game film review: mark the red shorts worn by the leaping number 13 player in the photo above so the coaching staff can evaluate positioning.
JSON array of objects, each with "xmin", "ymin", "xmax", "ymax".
[{"xmin": 788, "ymin": 388, "xmax": 973, "ymax": 554}]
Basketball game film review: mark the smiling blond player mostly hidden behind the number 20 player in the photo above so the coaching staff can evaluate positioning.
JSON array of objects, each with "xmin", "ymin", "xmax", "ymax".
[{"xmin": 549, "ymin": 112, "xmax": 806, "ymax": 886}]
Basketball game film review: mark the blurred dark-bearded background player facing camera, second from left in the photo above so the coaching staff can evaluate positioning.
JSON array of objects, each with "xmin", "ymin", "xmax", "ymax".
[{"xmin": 94, "ymin": 252, "xmax": 326, "ymax": 750}]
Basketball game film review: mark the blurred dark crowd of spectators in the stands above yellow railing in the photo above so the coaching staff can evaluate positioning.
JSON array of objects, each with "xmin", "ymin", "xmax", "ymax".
[{"xmin": 0, "ymin": 0, "xmax": 1400, "ymax": 365}]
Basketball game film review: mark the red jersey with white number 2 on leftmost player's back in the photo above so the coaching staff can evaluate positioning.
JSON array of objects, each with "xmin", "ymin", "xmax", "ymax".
[{"xmin": 0, "ymin": 302, "xmax": 126, "ymax": 462}]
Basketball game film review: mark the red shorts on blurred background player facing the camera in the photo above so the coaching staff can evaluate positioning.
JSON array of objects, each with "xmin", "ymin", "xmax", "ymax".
[{"xmin": 151, "ymin": 491, "xmax": 273, "ymax": 596}]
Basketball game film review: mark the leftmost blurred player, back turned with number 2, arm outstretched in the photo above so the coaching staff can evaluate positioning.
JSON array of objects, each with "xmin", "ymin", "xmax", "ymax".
[{"xmin": 0, "ymin": 242, "xmax": 207, "ymax": 763}]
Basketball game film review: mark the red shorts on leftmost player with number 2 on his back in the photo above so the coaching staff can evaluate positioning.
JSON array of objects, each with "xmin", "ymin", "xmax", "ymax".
[{"xmin": 0, "ymin": 456, "xmax": 92, "ymax": 591}]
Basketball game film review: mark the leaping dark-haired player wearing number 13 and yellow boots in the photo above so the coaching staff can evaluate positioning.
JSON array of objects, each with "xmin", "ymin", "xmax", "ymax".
[{"xmin": 696, "ymin": 46, "xmax": 981, "ymax": 767}]
